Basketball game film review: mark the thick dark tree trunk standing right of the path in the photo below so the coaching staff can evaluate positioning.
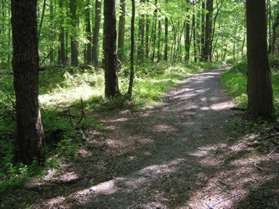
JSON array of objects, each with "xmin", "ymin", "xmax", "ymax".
[{"xmin": 246, "ymin": 0, "xmax": 273, "ymax": 119}]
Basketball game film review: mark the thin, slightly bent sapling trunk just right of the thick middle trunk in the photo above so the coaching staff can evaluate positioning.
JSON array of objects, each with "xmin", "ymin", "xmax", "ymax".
[{"xmin": 128, "ymin": 0, "xmax": 136, "ymax": 98}]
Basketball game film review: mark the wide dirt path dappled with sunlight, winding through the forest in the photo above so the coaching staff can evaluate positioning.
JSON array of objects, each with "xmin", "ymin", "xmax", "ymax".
[{"xmin": 0, "ymin": 70, "xmax": 279, "ymax": 209}]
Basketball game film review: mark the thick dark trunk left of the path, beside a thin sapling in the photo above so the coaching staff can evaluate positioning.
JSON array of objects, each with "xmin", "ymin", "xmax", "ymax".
[{"xmin": 104, "ymin": 0, "xmax": 119, "ymax": 98}]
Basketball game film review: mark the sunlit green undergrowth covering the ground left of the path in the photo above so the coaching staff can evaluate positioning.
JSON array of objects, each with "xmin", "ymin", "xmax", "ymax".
[{"xmin": 0, "ymin": 63, "xmax": 220, "ymax": 193}]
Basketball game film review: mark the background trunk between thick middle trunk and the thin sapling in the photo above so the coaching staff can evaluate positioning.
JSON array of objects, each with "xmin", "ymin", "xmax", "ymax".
[{"xmin": 118, "ymin": 0, "xmax": 126, "ymax": 61}]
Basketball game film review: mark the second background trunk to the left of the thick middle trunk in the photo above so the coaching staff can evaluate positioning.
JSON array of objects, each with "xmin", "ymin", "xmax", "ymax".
[{"xmin": 85, "ymin": 0, "xmax": 92, "ymax": 64}]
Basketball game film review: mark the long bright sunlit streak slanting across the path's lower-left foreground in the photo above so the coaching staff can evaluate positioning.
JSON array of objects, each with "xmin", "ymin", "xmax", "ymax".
[{"xmin": 37, "ymin": 159, "xmax": 185, "ymax": 208}]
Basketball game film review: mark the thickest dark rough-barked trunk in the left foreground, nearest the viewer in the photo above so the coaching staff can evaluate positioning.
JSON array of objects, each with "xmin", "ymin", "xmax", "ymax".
[{"xmin": 11, "ymin": 0, "xmax": 44, "ymax": 164}]
